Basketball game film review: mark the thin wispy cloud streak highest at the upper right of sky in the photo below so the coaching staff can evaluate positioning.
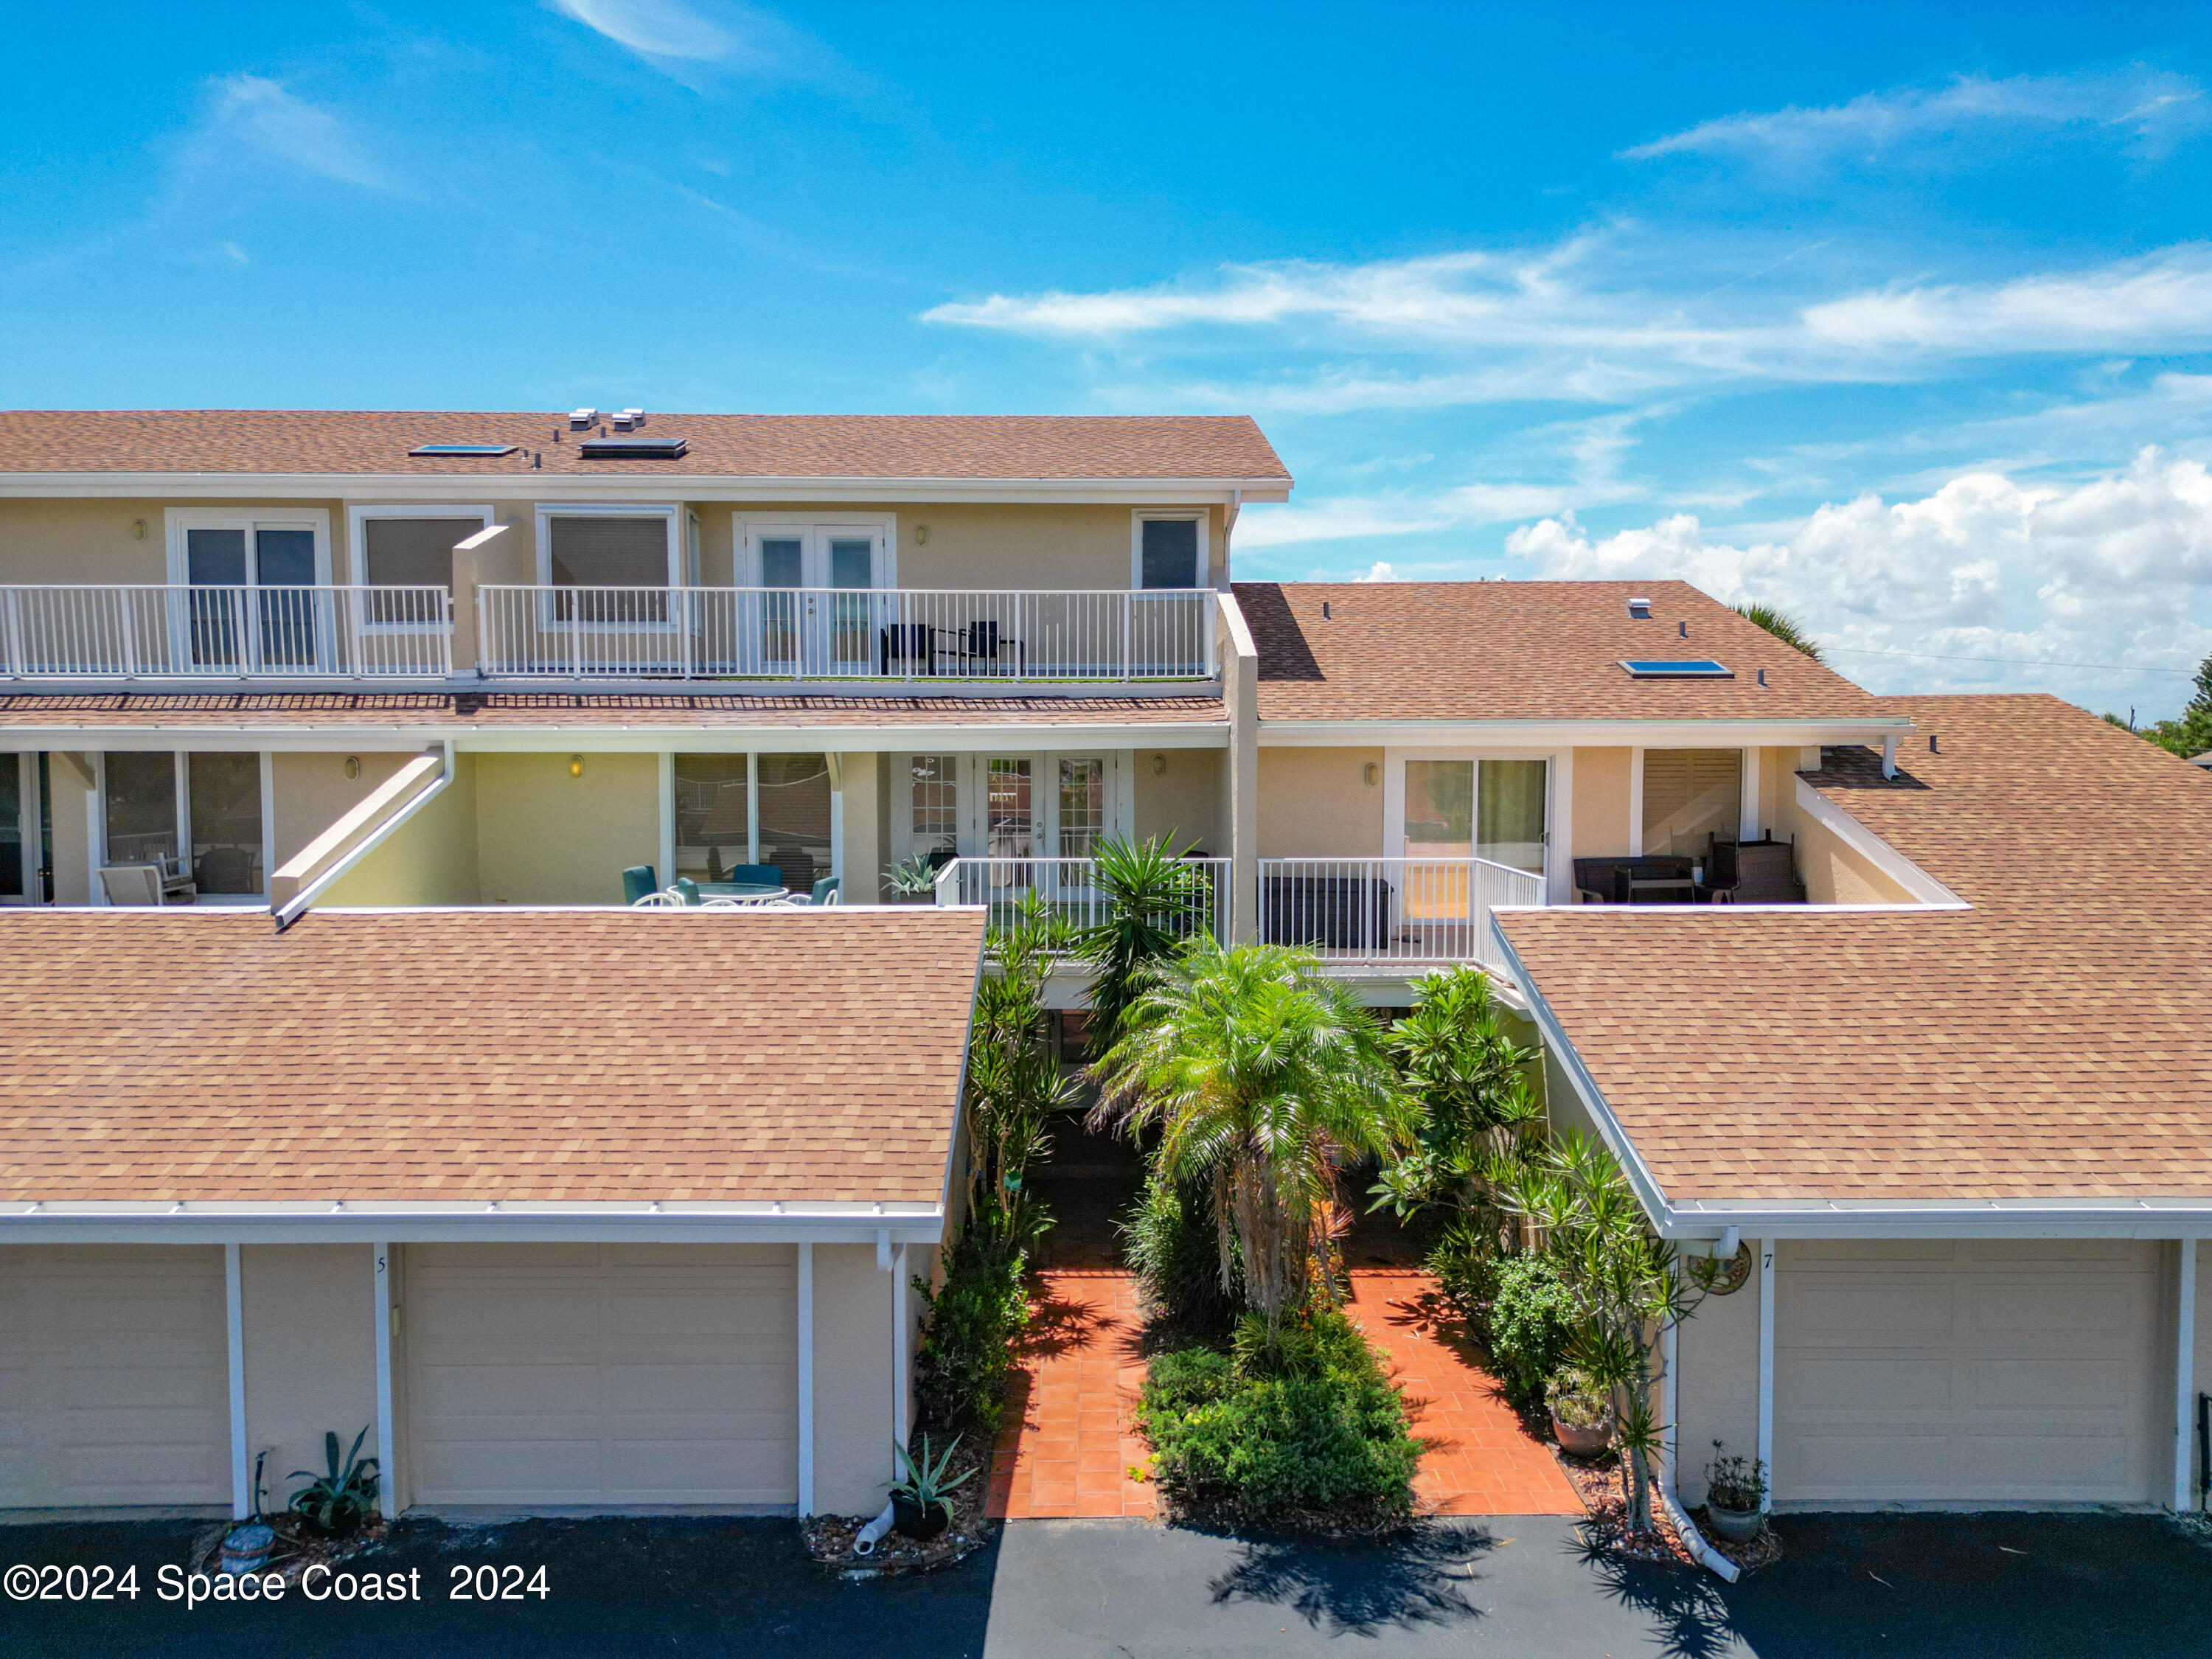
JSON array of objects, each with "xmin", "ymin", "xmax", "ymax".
[{"xmin": 1621, "ymin": 69, "xmax": 2212, "ymax": 164}]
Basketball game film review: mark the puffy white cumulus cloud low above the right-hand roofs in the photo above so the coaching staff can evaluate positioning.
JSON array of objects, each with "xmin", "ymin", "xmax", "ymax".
[{"xmin": 1506, "ymin": 449, "xmax": 2212, "ymax": 710}]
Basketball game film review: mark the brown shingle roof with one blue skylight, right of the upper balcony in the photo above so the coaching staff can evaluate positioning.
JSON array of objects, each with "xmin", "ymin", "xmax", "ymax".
[{"xmin": 1237, "ymin": 582, "xmax": 1876, "ymax": 721}]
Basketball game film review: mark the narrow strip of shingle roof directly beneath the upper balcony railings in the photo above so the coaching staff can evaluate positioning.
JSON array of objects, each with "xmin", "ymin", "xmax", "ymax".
[{"xmin": 0, "ymin": 692, "xmax": 1228, "ymax": 732}]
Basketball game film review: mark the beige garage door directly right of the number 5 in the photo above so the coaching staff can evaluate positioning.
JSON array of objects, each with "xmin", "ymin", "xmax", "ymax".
[{"xmin": 400, "ymin": 1245, "xmax": 799, "ymax": 1509}]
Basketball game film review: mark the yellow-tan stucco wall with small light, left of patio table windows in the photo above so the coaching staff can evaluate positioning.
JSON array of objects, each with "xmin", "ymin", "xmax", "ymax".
[{"xmin": 476, "ymin": 754, "xmax": 661, "ymax": 905}]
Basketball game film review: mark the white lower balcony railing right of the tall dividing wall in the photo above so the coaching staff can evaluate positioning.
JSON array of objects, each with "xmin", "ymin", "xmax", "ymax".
[{"xmin": 1259, "ymin": 858, "xmax": 1544, "ymax": 967}]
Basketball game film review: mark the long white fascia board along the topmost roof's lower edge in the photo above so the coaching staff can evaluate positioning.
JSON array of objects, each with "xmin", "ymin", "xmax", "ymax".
[{"xmin": 0, "ymin": 473, "xmax": 1290, "ymax": 507}]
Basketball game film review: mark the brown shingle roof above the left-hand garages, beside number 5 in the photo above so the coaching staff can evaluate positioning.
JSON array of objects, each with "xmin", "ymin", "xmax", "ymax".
[{"xmin": 0, "ymin": 907, "xmax": 982, "ymax": 1203}]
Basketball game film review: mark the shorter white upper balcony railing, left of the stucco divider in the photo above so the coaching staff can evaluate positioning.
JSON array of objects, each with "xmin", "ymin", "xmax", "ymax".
[{"xmin": 0, "ymin": 586, "xmax": 453, "ymax": 679}]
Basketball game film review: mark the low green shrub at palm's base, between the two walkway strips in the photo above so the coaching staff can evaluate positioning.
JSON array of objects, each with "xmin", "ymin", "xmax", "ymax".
[{"xmin": 1137, "ymin": 1310, "xmax": 1420, "ymax": 1517}]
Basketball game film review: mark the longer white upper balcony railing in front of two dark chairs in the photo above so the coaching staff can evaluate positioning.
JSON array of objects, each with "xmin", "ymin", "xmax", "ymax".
[{"xmin": 476, "ymin": 584, "xmax": 1217, "ymax": 681}]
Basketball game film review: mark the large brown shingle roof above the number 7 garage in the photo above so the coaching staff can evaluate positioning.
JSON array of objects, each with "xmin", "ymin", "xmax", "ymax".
[{"xmin": 1504, "ymin": 697, "xmax": 2212, "ymax": 1203}]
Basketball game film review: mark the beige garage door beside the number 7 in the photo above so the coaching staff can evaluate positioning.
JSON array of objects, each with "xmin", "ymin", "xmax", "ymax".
[{"xmin": 1774, "ymin": 1241, "xmax": 2172, "ymax": 1502}]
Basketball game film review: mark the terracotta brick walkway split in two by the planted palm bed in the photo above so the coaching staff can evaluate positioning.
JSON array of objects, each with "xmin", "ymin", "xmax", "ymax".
[{"xmin": 989, "ymin": 1267, "xmax": 1582, "ymax": 1520}]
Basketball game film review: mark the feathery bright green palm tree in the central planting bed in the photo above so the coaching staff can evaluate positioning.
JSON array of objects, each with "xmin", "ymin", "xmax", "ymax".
[{"xmin": 1095, "ymin": 940, "xmax": 1416, "ymax": 1338}]
